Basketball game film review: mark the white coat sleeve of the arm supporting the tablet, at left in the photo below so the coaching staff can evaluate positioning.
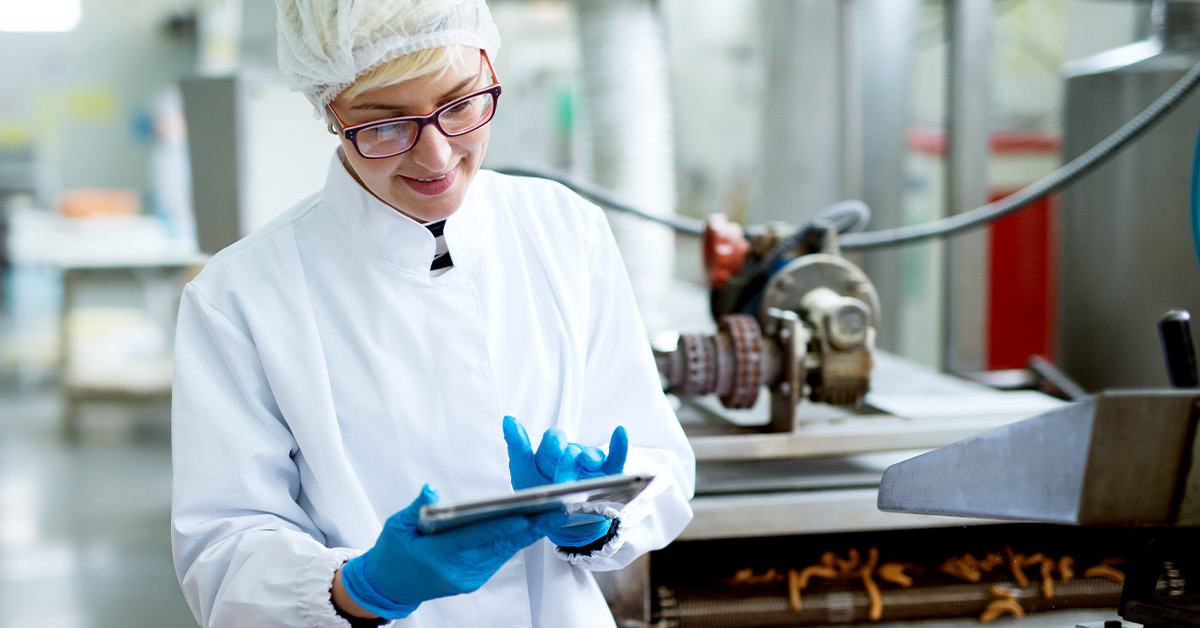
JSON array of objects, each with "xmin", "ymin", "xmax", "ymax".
[{"xmin": 172, "ymin": 285, "xmax": 358, "ymax": 627}]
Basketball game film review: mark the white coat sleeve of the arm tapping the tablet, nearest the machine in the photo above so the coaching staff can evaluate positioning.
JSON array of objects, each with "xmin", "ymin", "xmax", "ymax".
[{"xmin": 557, "ymin": 205, "xmax": 696, "ymax": 570}]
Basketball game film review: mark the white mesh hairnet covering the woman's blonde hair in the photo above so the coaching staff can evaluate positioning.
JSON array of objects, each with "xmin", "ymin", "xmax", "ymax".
[{"xmin": 275, "ymin": 0, "xmax": 500, "ymax": 109}]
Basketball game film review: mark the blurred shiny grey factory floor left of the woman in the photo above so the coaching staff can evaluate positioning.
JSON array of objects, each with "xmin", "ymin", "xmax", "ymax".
[{"xmin": 0, "ymin": 382, "xmax": 196, "ymax": 628}]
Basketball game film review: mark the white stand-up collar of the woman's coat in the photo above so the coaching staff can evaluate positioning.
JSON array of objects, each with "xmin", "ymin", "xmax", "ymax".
[{"xmin": 322, "ymin": 148, "xmax": 491, "ymax": 276}]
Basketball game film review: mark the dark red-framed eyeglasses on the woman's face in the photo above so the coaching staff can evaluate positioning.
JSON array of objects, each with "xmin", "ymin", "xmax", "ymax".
[{"xmin": 325, "ymin": 53, "xmax": 500, "ymax": 160}]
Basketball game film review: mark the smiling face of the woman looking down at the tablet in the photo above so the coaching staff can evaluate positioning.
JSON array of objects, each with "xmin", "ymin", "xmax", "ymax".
[{"xmin": 330, "ymin": 48, "xmax": 491, "ymax": 222}]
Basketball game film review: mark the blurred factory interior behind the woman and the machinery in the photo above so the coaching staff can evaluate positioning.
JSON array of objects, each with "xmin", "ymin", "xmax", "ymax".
[{"xmin": 0, "ymin": 0, "xmax": 1200, "ymax": 628}]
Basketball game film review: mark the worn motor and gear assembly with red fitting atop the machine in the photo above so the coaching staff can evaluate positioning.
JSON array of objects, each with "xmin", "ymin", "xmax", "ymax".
[{"xmin": 655, "ymin": 210, "xmax": 880, "ymax": 432}]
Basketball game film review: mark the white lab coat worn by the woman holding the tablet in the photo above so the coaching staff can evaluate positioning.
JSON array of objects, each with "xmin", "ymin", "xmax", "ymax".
[{"xmin": 172, "ymin": 157, "xmax": 695, "ymax": 628}]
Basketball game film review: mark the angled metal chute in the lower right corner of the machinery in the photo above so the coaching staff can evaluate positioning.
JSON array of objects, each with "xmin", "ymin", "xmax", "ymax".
[{"xmin": 878, "ymin": 389, "xmax": 1200, "ymax": 628}]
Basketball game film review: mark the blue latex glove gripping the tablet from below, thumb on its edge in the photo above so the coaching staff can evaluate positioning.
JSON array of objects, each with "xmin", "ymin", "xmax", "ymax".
[{"xmin": 342, "ymin": 485, "xmax": 566, "ymax": 620}]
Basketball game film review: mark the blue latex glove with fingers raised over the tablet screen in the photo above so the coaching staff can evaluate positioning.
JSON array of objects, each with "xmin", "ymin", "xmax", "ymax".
[{"xmin": 504, "ymin": 417, "xmax": 629, "ymax": 548}]
